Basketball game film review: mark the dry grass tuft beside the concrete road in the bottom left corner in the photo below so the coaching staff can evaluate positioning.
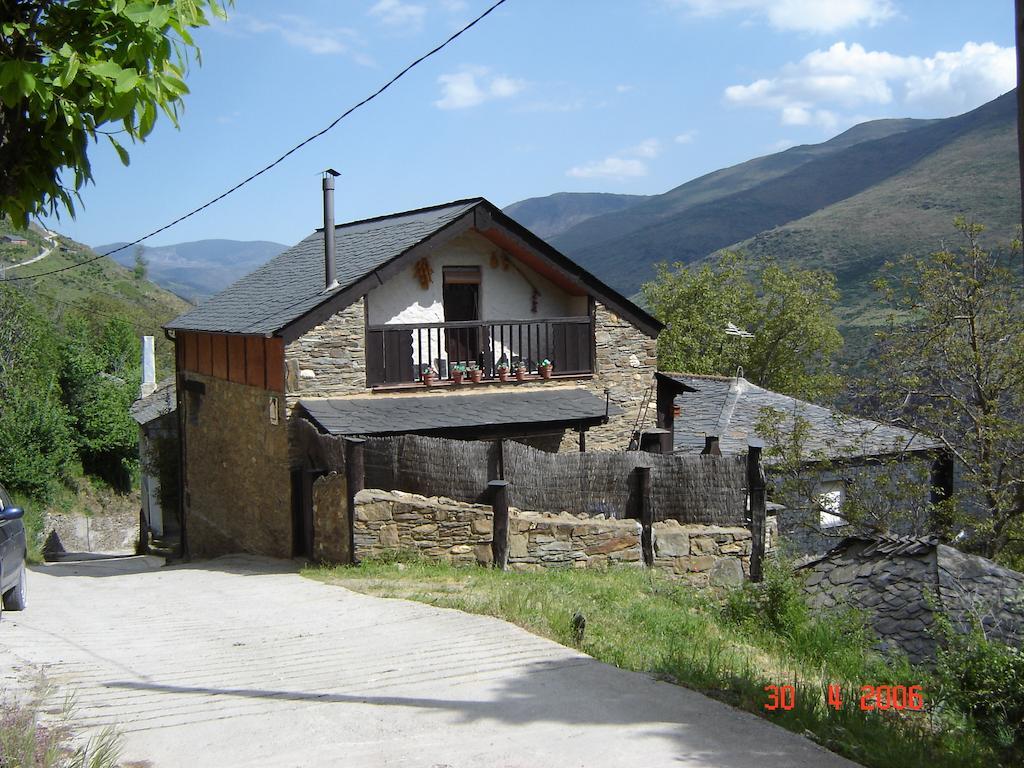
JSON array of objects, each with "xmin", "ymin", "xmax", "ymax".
[{"xmin": 0, "ymin": 678, "xmax": 128, "ymax": 768}]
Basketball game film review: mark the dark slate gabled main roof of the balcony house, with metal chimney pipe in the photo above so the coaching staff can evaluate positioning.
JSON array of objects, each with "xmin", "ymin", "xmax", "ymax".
[{"xmin": 166, "ymin": 198, "xmax": 663, "ymax": 336}]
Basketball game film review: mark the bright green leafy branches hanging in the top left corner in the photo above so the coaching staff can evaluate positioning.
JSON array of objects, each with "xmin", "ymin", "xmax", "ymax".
[{"xmin": 0, "ymin": 0, "xmax": 224, "ymax": 226}]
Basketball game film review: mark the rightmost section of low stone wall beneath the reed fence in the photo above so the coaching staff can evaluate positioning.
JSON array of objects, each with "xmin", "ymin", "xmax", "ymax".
[{"xmin": 653, "ymin": 517, "xmax": 778, "ymax": 587}]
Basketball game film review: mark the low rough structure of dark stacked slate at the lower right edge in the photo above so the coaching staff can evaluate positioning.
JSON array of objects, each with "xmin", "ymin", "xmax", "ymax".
[{"xmin": 798, "ymin": 537, "xmax": 1024, "ymax": 663}]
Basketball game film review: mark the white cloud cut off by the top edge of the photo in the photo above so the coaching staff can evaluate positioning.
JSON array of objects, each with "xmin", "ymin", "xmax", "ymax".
[{"xmin": 664, "ymin": 0, "xmax": 896, "ymax": 33}]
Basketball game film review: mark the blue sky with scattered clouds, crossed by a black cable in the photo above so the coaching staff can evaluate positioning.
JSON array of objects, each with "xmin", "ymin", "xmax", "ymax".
[{"xmin": 41, "ymin": 0, "xmax": 1016, "ymax": 245}]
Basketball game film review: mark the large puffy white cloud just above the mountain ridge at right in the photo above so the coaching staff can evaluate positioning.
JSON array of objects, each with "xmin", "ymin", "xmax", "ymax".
[{"xmin": 725, "ymin": 42, "xmax": 1017, "ymax": 129}]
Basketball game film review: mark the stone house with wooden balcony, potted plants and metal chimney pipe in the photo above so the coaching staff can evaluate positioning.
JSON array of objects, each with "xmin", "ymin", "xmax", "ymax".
[{"xmin": 166, "ymin": 196, "xmax": 662, "ymax": 556}]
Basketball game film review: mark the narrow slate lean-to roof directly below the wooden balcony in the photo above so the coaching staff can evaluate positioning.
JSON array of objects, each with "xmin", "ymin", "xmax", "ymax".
[{"xmin": 299, "ymin": 389, "xmax": 622, "ymax": 435}]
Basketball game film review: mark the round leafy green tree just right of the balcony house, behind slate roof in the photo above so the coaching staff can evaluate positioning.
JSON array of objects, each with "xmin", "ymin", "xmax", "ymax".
[{"xmin": 642, "ymin": 253, "xmax": 843, "ymax": 398}]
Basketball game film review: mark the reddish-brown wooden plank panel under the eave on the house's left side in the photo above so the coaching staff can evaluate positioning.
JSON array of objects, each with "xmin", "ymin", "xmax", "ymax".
[{"xmin": 175, "ymin": 331, "xmax": 285, "ymax": 392}]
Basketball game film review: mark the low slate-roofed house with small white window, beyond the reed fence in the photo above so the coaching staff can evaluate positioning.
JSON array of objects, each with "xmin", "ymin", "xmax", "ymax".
[{"xmin": 645, "ymin": 373, "xmax": 952, "ymax": 554}]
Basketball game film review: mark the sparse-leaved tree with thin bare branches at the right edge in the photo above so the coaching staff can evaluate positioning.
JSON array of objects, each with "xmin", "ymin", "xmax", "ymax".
[{"xmin": 871, "ymin": 218, "xmax": 1024, "ymax": 559}]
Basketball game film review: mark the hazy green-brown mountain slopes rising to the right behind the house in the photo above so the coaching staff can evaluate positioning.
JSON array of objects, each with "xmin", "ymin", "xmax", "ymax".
[{"xmin": 506, "ymin": 91, "xmax": 1021, "ymax": 364}]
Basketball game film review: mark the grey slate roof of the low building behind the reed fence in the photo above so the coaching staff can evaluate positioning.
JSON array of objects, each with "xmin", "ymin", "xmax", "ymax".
[{"xmin": 662, "ymin": 374, "xmax": 940, "ymax": 461}]
